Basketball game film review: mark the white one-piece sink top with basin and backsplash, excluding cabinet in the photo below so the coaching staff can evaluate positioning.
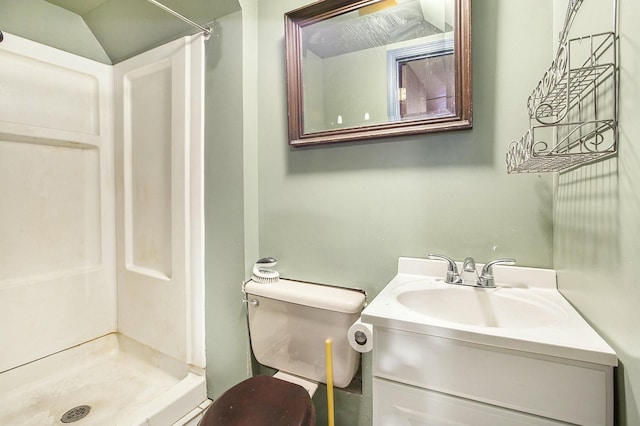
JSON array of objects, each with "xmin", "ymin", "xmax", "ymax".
[{"xmin": 361, "ymin": 258, "xmax": 617, "ymax": 365}]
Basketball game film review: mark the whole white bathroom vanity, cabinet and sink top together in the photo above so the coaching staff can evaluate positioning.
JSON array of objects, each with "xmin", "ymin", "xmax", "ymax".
[{"xmin": 361, "ymin": 258, "xmax": 617, "ymax": 426}]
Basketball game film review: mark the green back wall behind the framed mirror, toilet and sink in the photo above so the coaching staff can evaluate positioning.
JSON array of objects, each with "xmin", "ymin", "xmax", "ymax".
[{"xmin": 258, "ymin": 0, "xmax": 553, "ymax": 425}]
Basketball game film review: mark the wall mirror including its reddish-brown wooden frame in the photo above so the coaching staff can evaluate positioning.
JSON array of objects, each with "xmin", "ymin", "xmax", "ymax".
[{"xmin": 285, "ymin": 0, "xmax": 472, "ymax": 146}]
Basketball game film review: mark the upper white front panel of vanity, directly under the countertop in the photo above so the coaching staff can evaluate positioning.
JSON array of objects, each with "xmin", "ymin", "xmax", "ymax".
[{"xmin": 373, "ymin": 327, "xmax": 613, "ymax": 426}]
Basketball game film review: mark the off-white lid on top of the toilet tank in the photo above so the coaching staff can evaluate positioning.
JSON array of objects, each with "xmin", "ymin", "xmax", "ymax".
[{"xmin": 244, "ymin": 278, "xmax": 365, "ymax": 314}]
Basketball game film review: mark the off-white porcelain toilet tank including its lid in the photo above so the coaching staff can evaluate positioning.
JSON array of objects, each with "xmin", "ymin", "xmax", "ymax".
[{"xmin": 245, "ymin": 279, "xmax": 365, "ymax": 388}]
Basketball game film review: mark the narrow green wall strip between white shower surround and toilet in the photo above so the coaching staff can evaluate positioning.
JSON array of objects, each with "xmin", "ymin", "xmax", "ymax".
[{"xmin": 205, "ymin": 8, "xmax": 257, "ymax": 398}]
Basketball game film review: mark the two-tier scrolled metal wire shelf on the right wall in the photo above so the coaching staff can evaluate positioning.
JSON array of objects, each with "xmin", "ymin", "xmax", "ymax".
[{"xmin": 506, "ymin": 0, "xmax": 618, "ymax": 173}]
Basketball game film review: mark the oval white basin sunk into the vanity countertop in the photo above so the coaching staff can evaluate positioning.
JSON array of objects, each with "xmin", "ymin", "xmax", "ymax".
[{"xmin": 394, "ymin": 280, "xmax": 564, "ymax": 328}]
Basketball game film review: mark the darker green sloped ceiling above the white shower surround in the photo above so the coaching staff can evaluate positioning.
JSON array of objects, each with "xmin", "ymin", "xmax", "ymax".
[{"xmin": 40, "ymin": 0, "xmax": 240, "ymax": 64}]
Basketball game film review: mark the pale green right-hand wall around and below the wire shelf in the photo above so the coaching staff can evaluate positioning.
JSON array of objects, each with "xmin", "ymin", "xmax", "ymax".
[{"xmin": 553, "ymin": 0, "xmax": 640, "ymax": 425}]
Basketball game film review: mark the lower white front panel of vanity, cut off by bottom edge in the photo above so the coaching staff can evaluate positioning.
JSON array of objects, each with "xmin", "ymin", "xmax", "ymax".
[{"xmin": 373, "ymin": 377, "xmax": 569, "ymax": 426}]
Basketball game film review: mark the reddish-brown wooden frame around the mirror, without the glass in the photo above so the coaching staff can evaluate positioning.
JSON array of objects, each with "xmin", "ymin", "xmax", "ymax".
[{"xmin": 284, "ymin": 0, "xmax": 472, "ymax": 146}]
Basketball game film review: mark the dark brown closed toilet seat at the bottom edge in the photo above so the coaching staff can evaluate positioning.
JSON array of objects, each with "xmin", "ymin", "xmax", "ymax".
[{"xmin": 200, "ymin": 376, "xmax": 316, "ymax": 426}]
